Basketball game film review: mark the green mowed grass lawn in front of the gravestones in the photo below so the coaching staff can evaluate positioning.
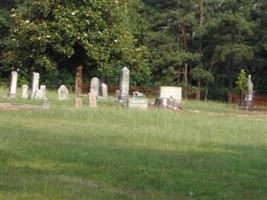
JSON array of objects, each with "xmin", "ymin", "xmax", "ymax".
[{"xmin": 0, "ymin": 93, "xmax": 267, "ymax": 200}]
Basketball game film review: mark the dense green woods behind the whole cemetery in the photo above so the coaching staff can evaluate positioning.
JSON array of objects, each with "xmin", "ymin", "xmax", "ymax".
[{"xmin": 0, "ymin": 0, "xmax": 267, "ymax": 99}]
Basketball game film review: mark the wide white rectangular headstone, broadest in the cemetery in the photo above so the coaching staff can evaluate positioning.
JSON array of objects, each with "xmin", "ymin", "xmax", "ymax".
[{"xmin": 159, "ymin": 86, "xmax": 182, "ymax": 103}]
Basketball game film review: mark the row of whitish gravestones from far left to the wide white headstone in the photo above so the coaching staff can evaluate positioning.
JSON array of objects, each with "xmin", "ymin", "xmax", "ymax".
[{"xmin": 8, "ymin": 67, "xmax": 182, "ymax": 111}]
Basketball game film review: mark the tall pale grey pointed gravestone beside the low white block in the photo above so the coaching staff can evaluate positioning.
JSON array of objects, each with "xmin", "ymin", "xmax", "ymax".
[{"xmin": 119, "ymin": 67, "xmax": 130, "ymax": 102}]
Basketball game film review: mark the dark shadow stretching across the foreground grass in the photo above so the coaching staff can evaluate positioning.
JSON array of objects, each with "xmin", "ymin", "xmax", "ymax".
[{"xmin": 0, "ymin": 143, "xmax": 267, "ymax": 200}]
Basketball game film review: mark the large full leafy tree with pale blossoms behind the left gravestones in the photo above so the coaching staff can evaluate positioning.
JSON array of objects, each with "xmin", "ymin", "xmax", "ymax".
[{"xmin": 2, "ymin": 0, "xmax": 149, "ymax": 90}]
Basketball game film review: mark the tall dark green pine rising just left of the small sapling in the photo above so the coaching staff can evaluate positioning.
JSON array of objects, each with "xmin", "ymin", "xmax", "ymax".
[{"xmin": 213, "ymin": 0, "xmax": 255, "ymax": 91}]
